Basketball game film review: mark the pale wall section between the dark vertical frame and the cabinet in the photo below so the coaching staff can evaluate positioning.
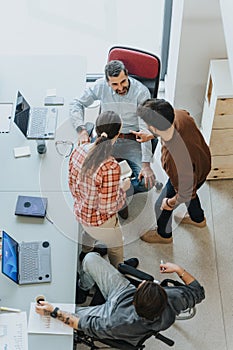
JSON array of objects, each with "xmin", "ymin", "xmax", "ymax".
[{"xmin": 165, "ymin": 0, "xmax": 227, "ymax": 123}]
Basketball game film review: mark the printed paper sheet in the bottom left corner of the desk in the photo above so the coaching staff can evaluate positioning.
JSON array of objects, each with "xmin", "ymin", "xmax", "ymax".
[{"xmin": 0, "ymin": 312, "xmax": 28, "ymax": 350}]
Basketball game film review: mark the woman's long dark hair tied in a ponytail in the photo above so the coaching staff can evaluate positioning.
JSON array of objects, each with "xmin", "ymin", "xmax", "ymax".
[{"xmin": 81, "ymin": 111, "xmax": 122, "ymax": 178}]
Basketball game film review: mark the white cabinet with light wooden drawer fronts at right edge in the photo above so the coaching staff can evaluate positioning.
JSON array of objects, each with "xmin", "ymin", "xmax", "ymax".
[{"xmin": 201, "ymin": 59, "xmax": 233, "ymax": 180}]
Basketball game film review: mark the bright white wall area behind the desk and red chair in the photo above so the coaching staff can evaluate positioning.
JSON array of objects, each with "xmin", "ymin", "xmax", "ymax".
[{"xmin": 0, "ymin": 0, "xmax": 164, "ymax": 72}]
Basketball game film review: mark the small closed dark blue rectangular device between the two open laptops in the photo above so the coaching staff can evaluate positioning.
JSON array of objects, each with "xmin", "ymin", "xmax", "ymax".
[{"xmin": 15, "ymin": 196, "xmax": 48, "ymax": 218}]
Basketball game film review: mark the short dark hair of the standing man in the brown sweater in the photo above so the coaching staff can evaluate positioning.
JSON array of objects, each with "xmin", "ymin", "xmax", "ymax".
[{"xmin": 137, "ymin": 98, "xmax": 175, "ymax": 131}]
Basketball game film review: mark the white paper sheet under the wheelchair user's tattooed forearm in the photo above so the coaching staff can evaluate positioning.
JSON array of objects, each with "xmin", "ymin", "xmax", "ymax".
[{"xmin": 28, "ymin": 303, "xmax": 75, "ymax": 335}]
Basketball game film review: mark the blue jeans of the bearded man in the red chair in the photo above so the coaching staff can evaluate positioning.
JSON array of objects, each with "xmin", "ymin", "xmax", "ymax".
[{"xmin": 113, "ymin": 139, "xmax": 158, "ymax": 197}]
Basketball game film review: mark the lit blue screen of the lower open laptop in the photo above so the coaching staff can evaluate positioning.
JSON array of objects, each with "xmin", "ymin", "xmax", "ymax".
[{"xmin": 2, "ymin": 231, "xmax": 18, "ymax": 283}]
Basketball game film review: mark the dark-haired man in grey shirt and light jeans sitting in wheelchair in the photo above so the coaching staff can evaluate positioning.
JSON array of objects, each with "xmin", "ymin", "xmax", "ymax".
[{"xmin": 36, "ymin": 252, "xmax": 205, "ymax": 346}]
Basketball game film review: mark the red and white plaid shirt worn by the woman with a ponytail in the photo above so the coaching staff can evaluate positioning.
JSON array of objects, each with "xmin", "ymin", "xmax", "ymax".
[{"xmin": 69, "ymin": 146, "xmax": 126, "ymax": 226}]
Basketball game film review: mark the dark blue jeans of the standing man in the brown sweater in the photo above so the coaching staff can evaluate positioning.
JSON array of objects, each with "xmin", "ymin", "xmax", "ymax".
[{"xmin": 155, "ymin": 179, "xmax": 204, "ymax": 238}]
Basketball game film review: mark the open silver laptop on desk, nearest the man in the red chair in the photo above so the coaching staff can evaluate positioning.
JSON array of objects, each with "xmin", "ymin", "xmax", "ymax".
[{"xmin": 14, "ymin": 91, "xmax": 57, "ymax": 140}]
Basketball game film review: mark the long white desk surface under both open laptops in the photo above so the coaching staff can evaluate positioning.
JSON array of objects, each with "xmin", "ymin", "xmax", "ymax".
[{"xmin": 0, "ymin": 56, "xmax": 86, "ymax": 350}]
